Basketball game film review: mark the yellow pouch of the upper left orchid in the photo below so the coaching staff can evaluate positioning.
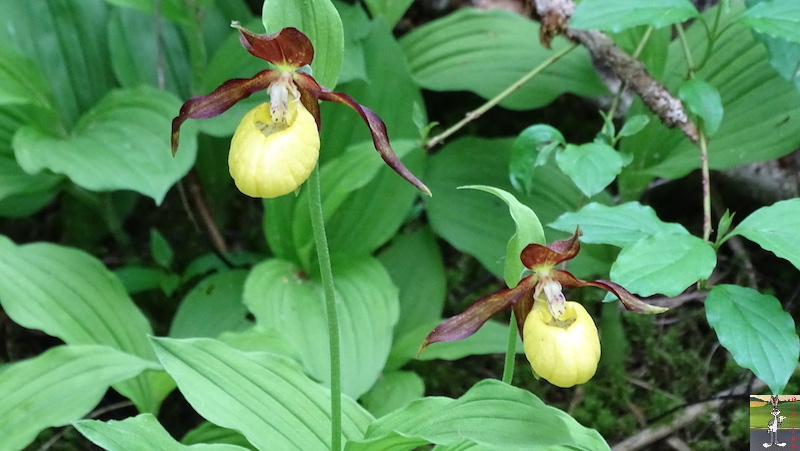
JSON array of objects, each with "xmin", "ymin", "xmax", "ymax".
[{"xmin": 228, "ymin": 101, "xmax": 319, "ymax": 198}]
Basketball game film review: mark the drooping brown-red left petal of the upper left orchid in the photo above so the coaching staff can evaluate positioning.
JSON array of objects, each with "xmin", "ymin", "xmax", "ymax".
[{"xmin": 172, "ymin": 69, "xmax": 280, "ymax": 155}]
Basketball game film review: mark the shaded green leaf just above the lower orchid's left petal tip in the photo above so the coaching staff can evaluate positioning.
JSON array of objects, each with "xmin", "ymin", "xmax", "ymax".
[{"xmin": 378, "ymin": 228, "xmax": 447, "ymax": 339}]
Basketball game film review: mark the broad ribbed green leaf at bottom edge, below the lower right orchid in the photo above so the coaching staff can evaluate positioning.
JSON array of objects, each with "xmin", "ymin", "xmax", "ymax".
[{"xmin": 346, "ymin": 379, "xmax": 609, "ymax": 451}]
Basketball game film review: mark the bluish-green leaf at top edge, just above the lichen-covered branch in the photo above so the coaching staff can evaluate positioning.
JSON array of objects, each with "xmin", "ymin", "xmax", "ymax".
[{"xmin": 569, "ymin": 0, "xmax": 698, "ymax": 32}]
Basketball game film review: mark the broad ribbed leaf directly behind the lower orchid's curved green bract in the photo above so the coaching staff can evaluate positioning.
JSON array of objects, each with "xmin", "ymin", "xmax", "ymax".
[{"xmin": 423, "ymin": 137, "xmax": 608, "ymax": 276}]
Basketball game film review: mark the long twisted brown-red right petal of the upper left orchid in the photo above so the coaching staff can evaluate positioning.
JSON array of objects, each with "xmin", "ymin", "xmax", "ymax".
[{"xmin": 295, "ymin": 73, "xmax": 431, "ymax": 196}]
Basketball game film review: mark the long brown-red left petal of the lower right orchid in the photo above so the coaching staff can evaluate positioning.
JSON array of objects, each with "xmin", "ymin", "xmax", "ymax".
[{"xmin": 419, "ymin": 275, "xmax": 536, "ymax": 352}]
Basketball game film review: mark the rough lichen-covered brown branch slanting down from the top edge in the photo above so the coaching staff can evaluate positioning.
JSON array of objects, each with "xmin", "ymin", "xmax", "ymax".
[{"xmin": 534, "ymin": 0, "xmax": 700, "ymax": 142}]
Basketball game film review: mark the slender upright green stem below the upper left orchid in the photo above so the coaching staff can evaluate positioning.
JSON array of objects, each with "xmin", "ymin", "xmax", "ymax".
[{"xmin": 307, "ymin": 163, "xmax": 342, "ymax": 451}]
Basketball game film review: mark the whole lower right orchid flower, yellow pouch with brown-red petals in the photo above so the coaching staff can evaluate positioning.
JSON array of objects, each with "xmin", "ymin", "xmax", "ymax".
[{"xmin": 420, "ymin": 229, "xmax": 667, "ymax": 387}]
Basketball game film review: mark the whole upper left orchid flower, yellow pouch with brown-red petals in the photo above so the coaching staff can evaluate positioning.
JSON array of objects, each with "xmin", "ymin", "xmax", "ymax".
[{"xmin": 172, "ymin": 22, "xmax": 430, "ymax": 198}]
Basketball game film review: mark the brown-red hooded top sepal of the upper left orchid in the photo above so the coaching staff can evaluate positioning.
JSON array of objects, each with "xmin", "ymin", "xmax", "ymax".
[{"xmin": 231, "ymin": 22, "xmax": 314, "ymax": 69}]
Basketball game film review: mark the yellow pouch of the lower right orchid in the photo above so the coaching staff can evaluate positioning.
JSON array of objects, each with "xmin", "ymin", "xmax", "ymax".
[{"xmin": 522, "ymin": 300, "xmax": 600, "ymax": 388}]
